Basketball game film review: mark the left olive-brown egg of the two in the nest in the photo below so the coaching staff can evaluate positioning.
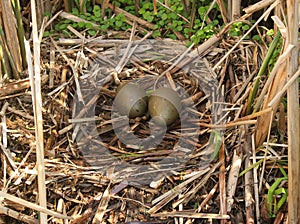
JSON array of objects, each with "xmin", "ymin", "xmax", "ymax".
[{"xmin": 114, "ymin": 83, "xmax": 148, "ymax": 118}]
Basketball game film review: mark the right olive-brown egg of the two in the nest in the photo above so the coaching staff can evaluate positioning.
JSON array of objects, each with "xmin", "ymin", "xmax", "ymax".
[{"xmin": 148, "ymin": 87, "xmax": 181, "ymax": 125}]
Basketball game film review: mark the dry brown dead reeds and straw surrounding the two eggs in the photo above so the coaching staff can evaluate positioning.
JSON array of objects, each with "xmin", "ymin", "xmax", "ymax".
[{"xmin": 0, "ymin": 1, "xmax": 299, "ymax": 224}]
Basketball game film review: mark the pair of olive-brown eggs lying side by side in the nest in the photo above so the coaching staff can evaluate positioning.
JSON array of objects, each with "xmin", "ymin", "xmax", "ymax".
[{"xmin": 114, "ymin": 83, "xmax": 181, "ymax": 126}]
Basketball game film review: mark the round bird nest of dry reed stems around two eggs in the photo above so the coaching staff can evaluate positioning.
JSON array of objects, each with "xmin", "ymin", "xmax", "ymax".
[{"xmin": 72, "ymin": 40, "xmax": 223, "ymax": 185}]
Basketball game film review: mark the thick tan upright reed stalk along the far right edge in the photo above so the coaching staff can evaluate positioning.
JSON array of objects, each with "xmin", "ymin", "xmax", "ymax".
[{"xmin": 287, "ymin": 0, "xmax": 300, "ymax": 223}]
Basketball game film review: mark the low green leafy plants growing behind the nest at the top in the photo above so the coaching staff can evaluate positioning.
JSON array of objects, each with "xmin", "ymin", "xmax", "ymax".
[{"xmin": 44, "ymin": 0, "xmax": 273, "ymax": 45}]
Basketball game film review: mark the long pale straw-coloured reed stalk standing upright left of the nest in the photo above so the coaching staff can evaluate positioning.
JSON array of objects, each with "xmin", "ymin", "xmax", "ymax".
[{"xmin": 26, "ymin": 0, "xmax": 47, "ymax": 223}]
